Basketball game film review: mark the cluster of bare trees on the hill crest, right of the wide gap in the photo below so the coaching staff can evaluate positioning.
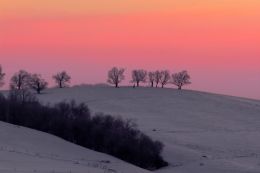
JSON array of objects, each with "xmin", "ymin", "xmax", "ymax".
[{"xmin": 107, "ymin": 67, "xmax": 191, "ymax": 90}]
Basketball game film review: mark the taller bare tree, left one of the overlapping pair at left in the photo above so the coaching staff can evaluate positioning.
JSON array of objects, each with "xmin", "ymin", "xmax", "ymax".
[{"xmin": 10, "ymin": 70, "xmax": 30, "ymax": 90}]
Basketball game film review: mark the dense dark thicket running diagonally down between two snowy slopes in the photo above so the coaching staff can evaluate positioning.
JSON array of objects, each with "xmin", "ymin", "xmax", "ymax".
[{"xmin": 0, "ymin": 89, "xmax": 167, "ymax": 170}]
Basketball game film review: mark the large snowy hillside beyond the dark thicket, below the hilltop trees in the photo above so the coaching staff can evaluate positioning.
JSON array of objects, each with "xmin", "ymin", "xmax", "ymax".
[{"xmin": 37, "ymin": 87, "xmax": 260, "ymax": 173}]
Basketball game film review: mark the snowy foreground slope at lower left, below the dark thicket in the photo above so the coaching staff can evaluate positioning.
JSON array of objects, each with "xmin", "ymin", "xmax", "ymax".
[{"xmin": 0, "ymin": 122, "xmax": 148, "ymax": 173}]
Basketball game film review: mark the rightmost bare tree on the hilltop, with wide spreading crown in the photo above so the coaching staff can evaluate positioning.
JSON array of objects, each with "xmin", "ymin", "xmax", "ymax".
[{"xmin": 172, "ymin": 70, "xmax": 191, "ymax": 90}]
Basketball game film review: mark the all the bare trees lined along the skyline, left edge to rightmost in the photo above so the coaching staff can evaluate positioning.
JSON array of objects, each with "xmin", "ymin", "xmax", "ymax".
[{"xmin": 0, "ymin": 65, "xmax": 191, "ymax": 94}]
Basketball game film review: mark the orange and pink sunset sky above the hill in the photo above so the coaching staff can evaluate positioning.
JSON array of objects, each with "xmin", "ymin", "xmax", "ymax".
[{"xmin": 0, "ymin": 0, "xmax": 260, "ymax": 99}]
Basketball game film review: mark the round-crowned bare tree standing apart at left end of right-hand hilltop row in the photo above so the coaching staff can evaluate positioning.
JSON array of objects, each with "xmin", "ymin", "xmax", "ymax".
[{"xmin": 107, "ymin": 67, "xmax": 125, "ymax": 88}]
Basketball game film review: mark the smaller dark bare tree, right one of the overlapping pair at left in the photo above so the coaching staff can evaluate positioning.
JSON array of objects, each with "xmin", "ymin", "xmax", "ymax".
[{"xmin": 29, "ymin": 74, "xmax": 48, "ymax": 94}]
